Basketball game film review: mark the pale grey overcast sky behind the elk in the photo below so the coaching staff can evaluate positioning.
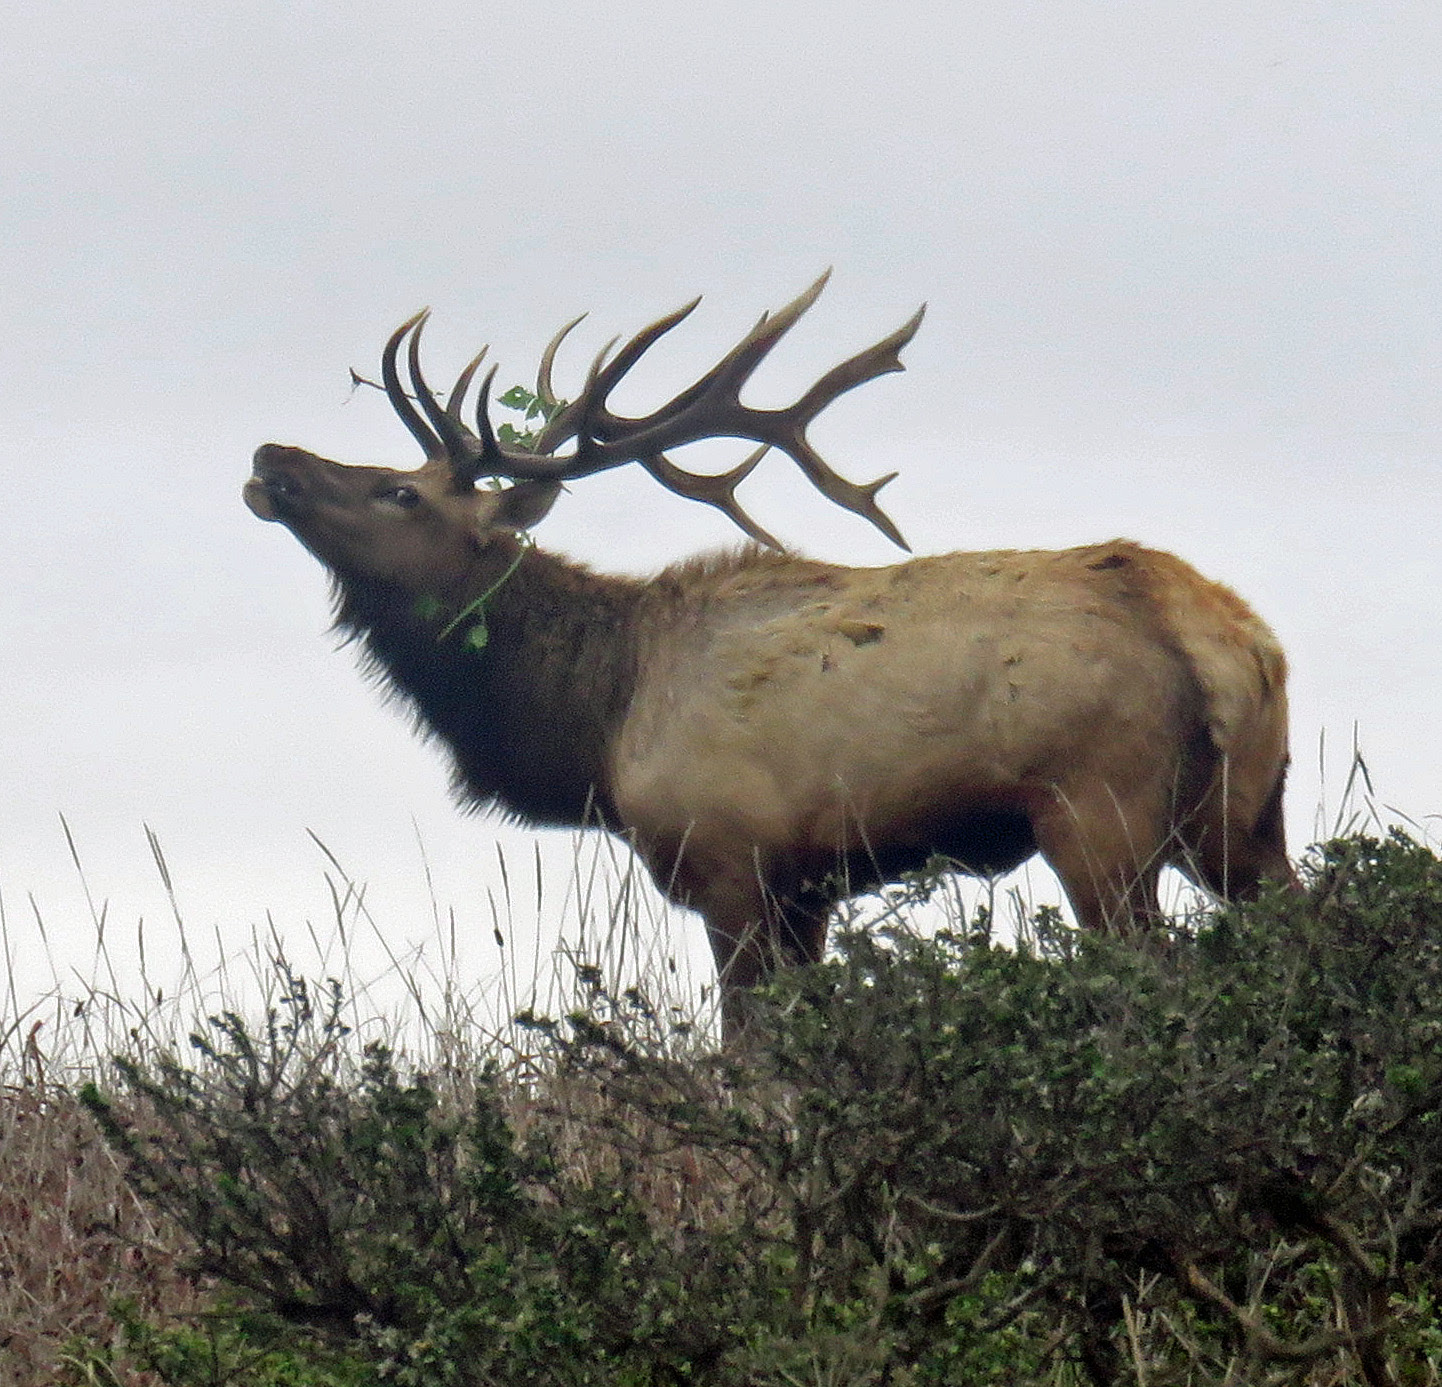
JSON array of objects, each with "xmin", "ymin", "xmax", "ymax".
[{"xmin": 0, "ymin": 0, "xmax": 1442, "ymax": 1026}]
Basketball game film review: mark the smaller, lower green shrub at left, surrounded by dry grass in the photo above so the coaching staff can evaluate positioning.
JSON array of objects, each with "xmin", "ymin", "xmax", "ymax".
[{"xmin": 73, "ymin": 965, "xmax": 751, "ymax": 1387}]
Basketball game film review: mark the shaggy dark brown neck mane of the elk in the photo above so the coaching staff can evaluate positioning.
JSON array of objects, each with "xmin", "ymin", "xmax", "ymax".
[{"xmin": 336, "ymin": 541, "xmax": 643, "ymax": 826}]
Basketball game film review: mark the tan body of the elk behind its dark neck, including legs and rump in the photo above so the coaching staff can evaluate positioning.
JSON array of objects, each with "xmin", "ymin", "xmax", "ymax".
[{"xmin": 613, "ymin": 541, "xmax": 1291, "ymax": 1003}]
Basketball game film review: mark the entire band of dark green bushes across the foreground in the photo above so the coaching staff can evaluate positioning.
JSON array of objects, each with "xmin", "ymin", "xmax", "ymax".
[{"xmin": 73, "ymin": 836, "xmax": 1442, "ymax": 1387}]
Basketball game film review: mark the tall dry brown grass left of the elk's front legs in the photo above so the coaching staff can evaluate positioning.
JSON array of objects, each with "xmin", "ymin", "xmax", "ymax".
[{"xmin": 0, "ymin": 818, "xmax": 714, "ymax": 1387}]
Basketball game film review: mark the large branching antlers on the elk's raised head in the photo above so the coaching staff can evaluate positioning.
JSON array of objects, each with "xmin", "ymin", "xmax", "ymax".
[{"xmin": 382, "ymin": 270, "xmax": 926, "ymax": 549}]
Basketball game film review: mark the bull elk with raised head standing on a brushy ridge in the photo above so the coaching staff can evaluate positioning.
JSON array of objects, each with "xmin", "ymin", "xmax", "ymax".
[{"xmin": 244, "ymin": 275, "xmax": 1292, "ymax": 1034}]
